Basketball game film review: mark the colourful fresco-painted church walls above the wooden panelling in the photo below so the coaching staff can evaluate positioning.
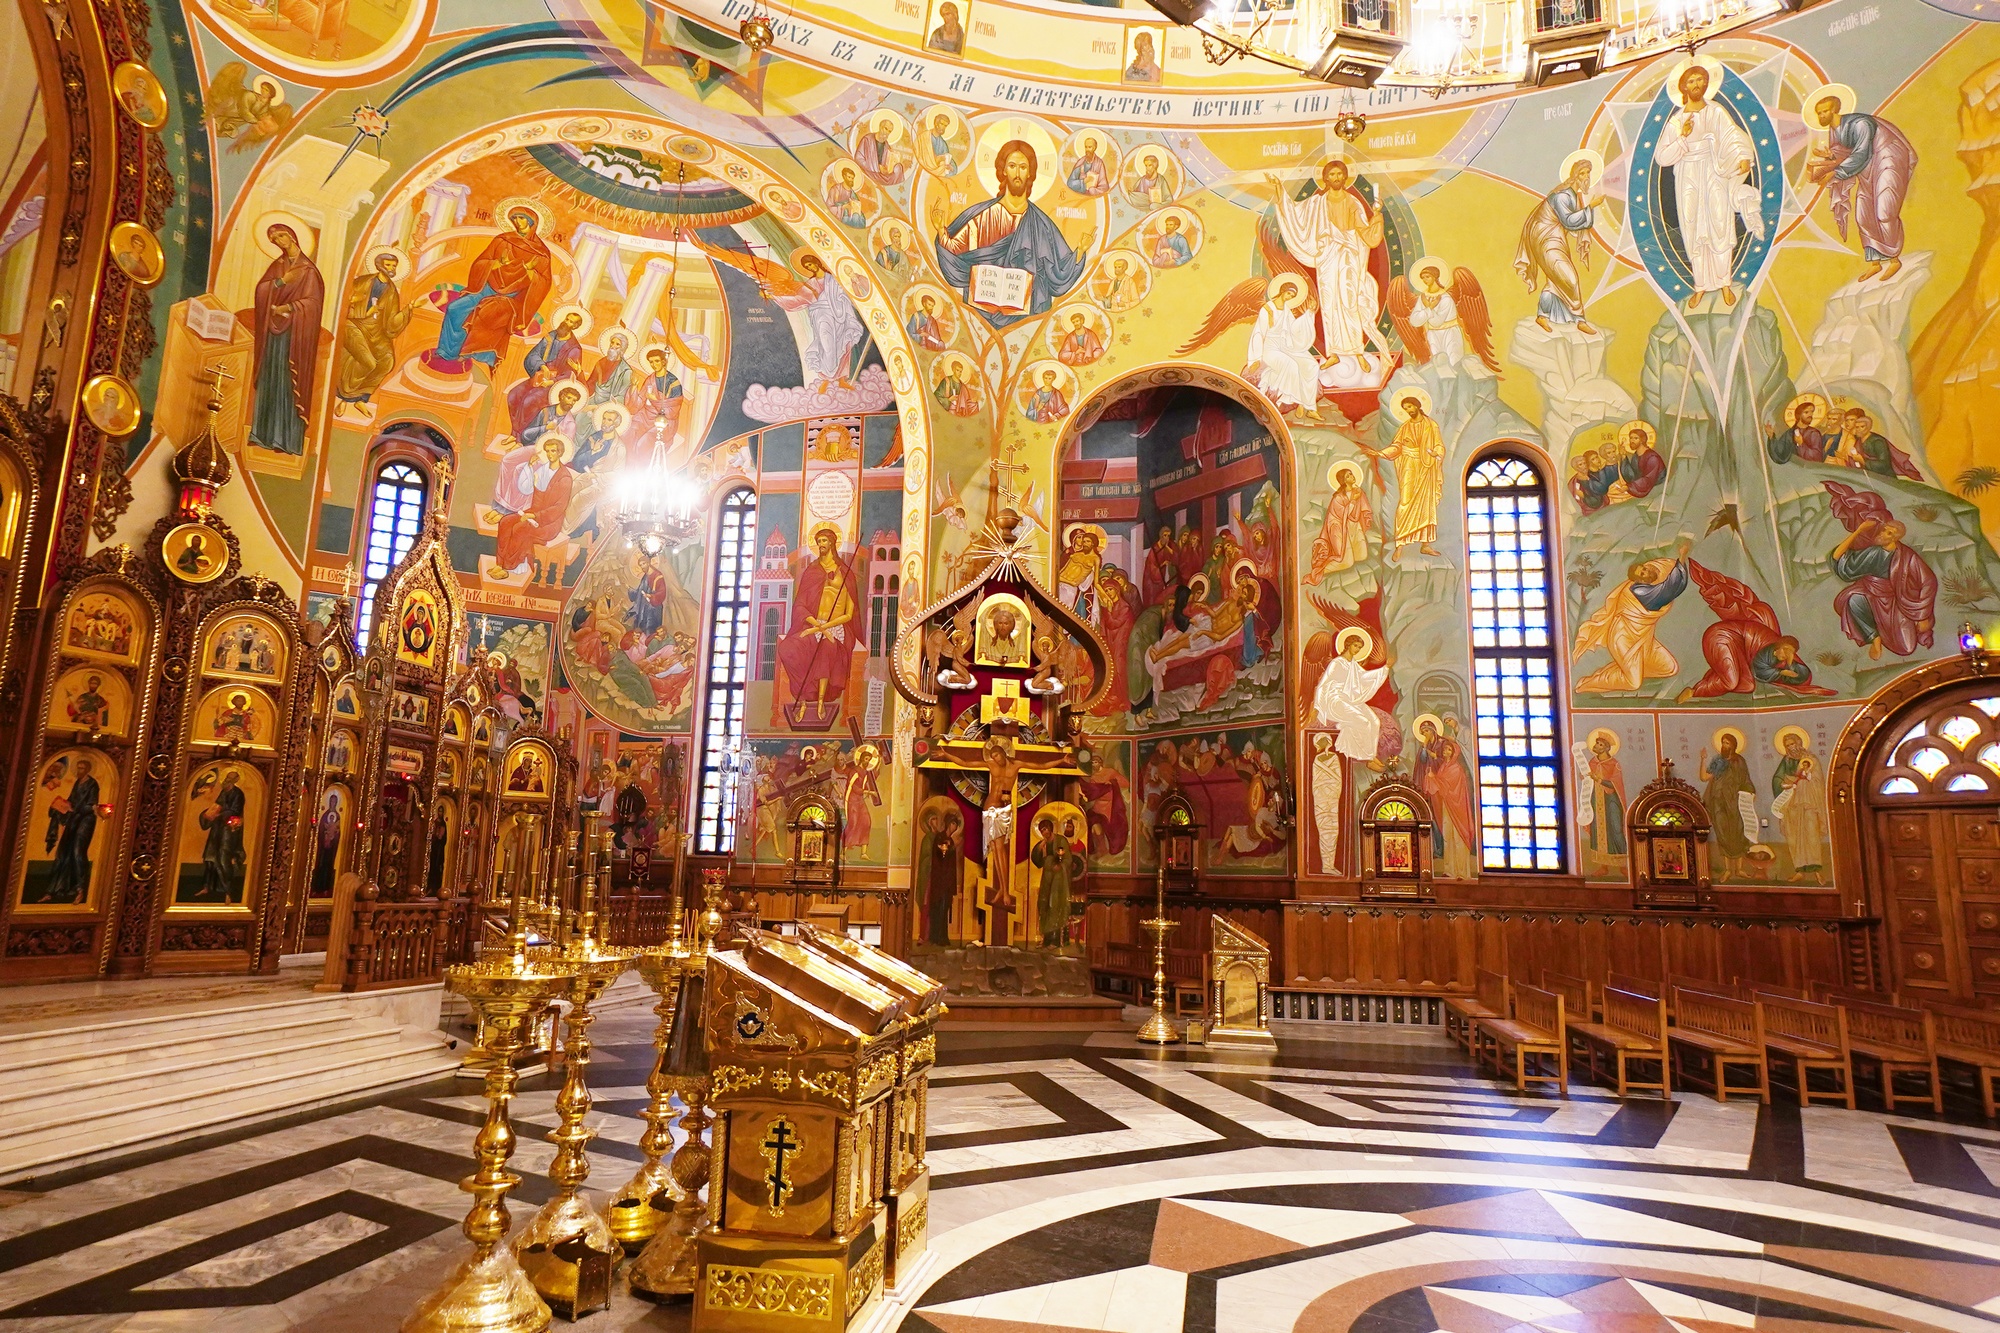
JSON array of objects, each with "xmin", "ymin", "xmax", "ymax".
[{"xmin": 19, "ymin": 0, "xmax": 2000, "ymax": 956}]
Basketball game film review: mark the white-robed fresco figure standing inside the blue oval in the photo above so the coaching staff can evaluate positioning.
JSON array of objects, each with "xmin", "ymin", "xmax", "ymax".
[{"xmin": 1654, "ymin": 62, "xmax": 1764, "ymax": 310}]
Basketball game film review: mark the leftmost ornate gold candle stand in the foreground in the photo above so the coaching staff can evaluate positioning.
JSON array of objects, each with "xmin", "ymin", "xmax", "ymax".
[{"xmin": 402, "ymin": 815, "xmax": 574, "ymax": 1333}]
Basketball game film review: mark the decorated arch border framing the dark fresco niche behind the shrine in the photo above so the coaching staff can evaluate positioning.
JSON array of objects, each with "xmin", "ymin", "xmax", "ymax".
[{"xmin": 1048, "ymin": 362, "xmax": 1308, "ymax": 873}]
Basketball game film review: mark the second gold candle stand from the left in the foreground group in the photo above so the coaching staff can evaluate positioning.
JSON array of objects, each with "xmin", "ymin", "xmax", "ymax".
[{"xmin": 514, "ymin": 811, "xmax": 638, "ymax": 1319}]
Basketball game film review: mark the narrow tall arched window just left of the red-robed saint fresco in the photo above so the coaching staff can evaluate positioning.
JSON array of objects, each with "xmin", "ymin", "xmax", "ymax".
[{"xmin": 694, "ymin": 486, "xmax": 756, "ymax": 855}]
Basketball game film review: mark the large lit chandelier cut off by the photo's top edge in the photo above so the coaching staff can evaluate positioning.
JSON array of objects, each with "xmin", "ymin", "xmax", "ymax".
[{"xmin": 1150, "ymin": 0, "xmax": 1818, "ymax": 96}]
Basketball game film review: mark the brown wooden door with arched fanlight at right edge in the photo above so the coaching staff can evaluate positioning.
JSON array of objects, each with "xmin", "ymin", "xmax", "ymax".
[{"xmin": 1862, "ymin": 683, "xmax": 2000, "ymax": 1003}]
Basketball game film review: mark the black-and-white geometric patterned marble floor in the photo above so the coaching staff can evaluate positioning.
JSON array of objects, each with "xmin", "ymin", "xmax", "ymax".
[{"xmin": 0, "ymin": 1009, "xmax": 2000, "ymax": 1333}]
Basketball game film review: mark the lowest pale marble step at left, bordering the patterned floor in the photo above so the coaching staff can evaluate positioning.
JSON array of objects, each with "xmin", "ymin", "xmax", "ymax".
[{"xmin": 0, "ymin": 1041, "xmax": 458, "ymax": 1183}]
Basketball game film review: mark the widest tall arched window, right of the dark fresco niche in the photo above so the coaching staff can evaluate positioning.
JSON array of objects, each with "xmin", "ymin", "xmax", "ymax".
[{"xmin": 1466, "ymin": 454, "xmax": 1566, "ymax": 873}]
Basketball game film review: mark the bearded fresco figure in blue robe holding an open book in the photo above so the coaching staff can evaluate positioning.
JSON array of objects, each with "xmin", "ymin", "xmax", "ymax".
[{"xmin": 932, "ymin": 138, "xmax": 1090, "ymax": 328}]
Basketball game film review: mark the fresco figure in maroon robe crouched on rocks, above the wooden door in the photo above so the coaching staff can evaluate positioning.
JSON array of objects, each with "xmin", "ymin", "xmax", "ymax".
[{"xmin": 1824, "ymin": 480, "xmax": 1938, "ymax": 658}]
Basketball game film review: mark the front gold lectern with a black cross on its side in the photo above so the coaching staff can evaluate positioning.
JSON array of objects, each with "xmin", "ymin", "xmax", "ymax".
[{"xmin": 694, "ymin": 929, "xmax": 912, "ymax": 1333}]
